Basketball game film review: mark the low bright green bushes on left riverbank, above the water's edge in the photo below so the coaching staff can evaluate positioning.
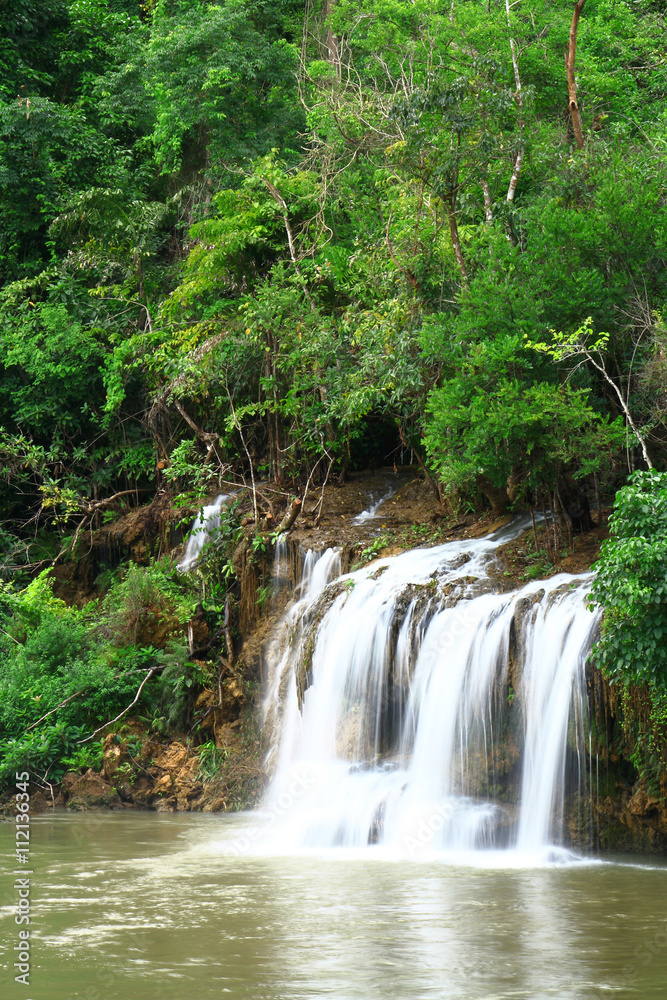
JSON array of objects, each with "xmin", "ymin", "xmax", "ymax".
[{"xmin": 0, "ymin": 564, "xmax": 202, "ymax": 787}]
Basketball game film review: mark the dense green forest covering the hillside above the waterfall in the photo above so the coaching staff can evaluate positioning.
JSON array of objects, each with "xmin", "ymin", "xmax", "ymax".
[{"xmin": 0, "ymin": 0, "xmax": 667, "ymax": 700}]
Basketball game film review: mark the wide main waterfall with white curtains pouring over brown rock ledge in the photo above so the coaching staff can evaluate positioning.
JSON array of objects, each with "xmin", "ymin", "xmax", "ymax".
[{"xmin": 265, "ymin": 523, "xmax": 596, "ymax": 857}]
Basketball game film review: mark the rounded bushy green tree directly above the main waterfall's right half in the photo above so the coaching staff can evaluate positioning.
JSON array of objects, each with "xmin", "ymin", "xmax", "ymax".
[{"xmin": 424, "ymin": 335, "xmax": 619, "ymax": 516}]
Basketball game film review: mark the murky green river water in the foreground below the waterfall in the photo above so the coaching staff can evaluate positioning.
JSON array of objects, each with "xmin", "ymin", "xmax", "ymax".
[{"xmin": 0, "ymin": 813, "xmax": 667, "ymax": 1000}]
